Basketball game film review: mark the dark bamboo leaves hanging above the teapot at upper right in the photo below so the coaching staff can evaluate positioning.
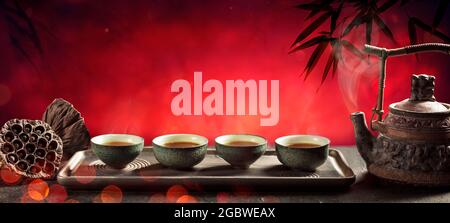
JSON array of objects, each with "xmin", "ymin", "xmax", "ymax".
[{"xmin": 289, "ymin": 0, "xmax": 450, "ymax": 83}]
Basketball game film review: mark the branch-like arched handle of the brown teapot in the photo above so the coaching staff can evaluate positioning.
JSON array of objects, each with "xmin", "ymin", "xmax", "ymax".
[{"xmin": 364, "ymin": 43, "xmax": 450, "ymax": 130}]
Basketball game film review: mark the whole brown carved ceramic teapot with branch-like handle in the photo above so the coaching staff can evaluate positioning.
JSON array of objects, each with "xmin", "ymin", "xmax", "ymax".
[{"xmin": 351, "ymin": 43, "xmax": 450, "ymax": 186}]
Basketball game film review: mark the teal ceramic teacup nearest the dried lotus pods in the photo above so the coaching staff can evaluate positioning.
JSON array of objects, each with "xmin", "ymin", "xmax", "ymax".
[{"xmin": 91, "ymin": 134, "xmax": 144, "ymax": 169}]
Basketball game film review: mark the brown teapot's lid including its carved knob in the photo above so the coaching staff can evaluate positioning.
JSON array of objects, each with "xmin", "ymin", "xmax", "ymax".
[{"xmin": 390, "ymin": 74, "xmax": 449, "ymax": 113}]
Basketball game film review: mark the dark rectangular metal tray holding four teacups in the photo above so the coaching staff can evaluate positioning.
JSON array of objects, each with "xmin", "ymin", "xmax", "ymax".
[{"xmin": 57, "ymin": 147, "xmax": 356, "ymax": 189}]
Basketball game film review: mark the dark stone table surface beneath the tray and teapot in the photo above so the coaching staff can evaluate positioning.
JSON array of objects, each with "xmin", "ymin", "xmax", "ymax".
[{"xmin": 0, "ymin": 147, "xmax": 450, "ymax": 203}]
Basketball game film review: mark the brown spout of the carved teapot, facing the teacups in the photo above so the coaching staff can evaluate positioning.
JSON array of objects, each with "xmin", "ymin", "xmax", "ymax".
[{"xmin": 351, "ymin": 112, "xmax": 376, "ymax": 164}]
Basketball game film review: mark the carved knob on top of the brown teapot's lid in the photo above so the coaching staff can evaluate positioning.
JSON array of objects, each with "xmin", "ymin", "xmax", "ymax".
[{"xmin": 409, "ymin": 74, "xmax": 436, "ymax": 101}]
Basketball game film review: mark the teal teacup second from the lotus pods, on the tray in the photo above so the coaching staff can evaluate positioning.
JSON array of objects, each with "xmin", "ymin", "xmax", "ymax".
[{"xmin": 152, "ymin": 134, "xmax": 208, "ymax": 169}]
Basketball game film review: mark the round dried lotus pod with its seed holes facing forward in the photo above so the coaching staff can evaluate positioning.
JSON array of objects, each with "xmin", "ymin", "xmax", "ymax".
[{"xmin": 0, "ymin": 119, "xmax": 63, "ymax": 178}]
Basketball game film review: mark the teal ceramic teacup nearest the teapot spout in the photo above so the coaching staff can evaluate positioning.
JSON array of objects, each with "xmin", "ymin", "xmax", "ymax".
[{"xmin": 275, "ymin": 135, "xmax": 330, "ymax": 171}]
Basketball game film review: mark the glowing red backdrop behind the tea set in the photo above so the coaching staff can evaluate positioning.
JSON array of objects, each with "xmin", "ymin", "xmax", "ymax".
[{"xmin": 0, "ymin": 0, "xmax": 450, "ymax": 145}]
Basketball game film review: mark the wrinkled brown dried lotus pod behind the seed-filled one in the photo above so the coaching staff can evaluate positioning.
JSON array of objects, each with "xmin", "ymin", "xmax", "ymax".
[{"xmin": 42, "ymin": 98, "xmax": 91, "ymax": 160}]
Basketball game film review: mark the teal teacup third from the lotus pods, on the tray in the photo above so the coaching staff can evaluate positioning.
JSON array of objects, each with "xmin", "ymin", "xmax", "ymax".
[{"xmin": 215, "ymin": 134, "xmax": 267, "ymax": 169}]
